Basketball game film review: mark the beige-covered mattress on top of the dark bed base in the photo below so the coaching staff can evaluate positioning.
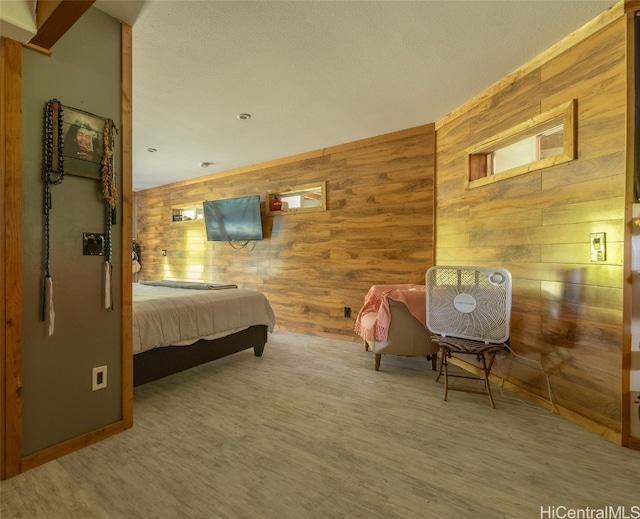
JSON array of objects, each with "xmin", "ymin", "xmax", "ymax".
[{"xmin": 133, "ymin": 283, "xmax": 275, "ymax": 354}]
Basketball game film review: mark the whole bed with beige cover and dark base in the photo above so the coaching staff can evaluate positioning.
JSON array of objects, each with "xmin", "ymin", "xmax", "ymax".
[{"xmin": 133, "ymin": 281, "xmax": 275, "ymax": 386}]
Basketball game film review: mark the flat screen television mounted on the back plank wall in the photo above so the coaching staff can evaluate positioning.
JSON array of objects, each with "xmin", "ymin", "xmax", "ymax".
[{"xmin": 203, "ymin": 195, "xmax": 263, "ymax": 241}]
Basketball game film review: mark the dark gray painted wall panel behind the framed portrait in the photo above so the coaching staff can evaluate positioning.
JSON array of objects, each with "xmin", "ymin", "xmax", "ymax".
[{"xmin": 22, "ymin": 8, "xmax": 122, "ymax": 456}]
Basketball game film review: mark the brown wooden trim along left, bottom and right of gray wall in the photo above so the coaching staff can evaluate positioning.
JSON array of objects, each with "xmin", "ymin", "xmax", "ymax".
[{"xmin": 0, "ymin": 24, "xmax": 133, "ymax": 480}]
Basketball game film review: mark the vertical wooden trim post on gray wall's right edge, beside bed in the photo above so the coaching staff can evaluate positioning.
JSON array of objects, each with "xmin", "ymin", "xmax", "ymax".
[{"xmin": 121, "ymin": 23, "xmax": 133, "ymax": 429}]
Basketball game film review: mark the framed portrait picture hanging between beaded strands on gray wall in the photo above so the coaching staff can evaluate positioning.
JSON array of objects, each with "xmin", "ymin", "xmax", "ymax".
[{"xmin": 62, "ymin": 106, "xmax": 106, "ymax": 180}]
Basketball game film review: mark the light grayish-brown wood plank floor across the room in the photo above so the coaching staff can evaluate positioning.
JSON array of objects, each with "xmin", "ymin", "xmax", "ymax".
[{"xmin": 0, "ymin": 332, "xmax": 640, "ymax": 519}]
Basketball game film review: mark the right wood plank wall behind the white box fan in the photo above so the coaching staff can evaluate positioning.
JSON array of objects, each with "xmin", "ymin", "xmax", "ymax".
[{"xmin": 436, "ymin": 19, "xmax": 626, "ymax": 440}]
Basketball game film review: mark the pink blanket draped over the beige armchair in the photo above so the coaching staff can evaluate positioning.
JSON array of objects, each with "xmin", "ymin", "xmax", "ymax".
[{"xmin": 355, "ymin": 284, "xmax": 427, "ymax": 341}]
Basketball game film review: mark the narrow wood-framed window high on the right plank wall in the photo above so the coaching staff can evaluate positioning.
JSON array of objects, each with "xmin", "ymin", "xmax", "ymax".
[{"xmin": 465, "ymin": 100, "xmax": 576, "ymax": 189}]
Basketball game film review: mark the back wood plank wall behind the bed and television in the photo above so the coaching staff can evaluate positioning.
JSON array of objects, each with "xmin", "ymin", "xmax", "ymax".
[{"xmin": 135, "ymin": 124, "xmax": 435, "ymax": 340}]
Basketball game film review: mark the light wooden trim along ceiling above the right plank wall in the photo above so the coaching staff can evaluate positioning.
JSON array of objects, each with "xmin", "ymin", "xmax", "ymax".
[{"xmin": 435, "ymin": 0, "xmax": 625, "ymax": 131}]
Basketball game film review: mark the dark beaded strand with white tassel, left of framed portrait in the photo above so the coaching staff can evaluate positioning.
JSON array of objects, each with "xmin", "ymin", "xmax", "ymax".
[{"xmin": 40, "ymin": 99, "xmax": 64, "ymax": 336}]
